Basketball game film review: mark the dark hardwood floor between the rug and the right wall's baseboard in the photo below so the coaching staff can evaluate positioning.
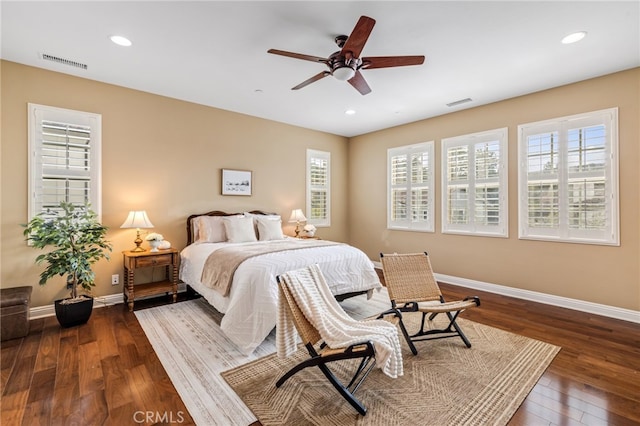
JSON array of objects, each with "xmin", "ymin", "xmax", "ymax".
[{"xmin": 441, "ymin": 284, "xmax": 640, "ymax": 426}]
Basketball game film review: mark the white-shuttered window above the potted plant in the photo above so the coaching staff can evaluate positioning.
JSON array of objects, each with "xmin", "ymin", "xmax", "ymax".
[{"xmin": 28, "ymin": 104, "xmax": 101, "ymax": 219}]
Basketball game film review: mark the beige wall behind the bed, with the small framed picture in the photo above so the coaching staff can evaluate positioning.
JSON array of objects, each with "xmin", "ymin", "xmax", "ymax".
[{"xmin": 0, "ymin": 61, "xmax": 348, "ymax": 306}]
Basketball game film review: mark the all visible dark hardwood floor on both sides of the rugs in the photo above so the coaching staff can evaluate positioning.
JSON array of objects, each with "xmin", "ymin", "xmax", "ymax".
[{"xmin": 0, "ymin": 285, "xmax": 640, "ymax": 426}]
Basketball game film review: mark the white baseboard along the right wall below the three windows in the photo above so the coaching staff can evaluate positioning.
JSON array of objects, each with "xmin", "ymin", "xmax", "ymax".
[{"xmin": 374, "ymin": 262, "xmax": 640, "ymax": 324}]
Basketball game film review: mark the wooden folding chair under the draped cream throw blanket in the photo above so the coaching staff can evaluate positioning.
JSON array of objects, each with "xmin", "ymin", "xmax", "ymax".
[{"xmin": 276, "ymin": 268, "xmax": 401, "ymax": 416}]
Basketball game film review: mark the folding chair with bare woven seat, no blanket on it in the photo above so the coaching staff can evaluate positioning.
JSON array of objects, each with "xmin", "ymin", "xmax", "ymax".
[{"xmin": 380, "ymin": 252, "xmax": 480, "ymax": 355}]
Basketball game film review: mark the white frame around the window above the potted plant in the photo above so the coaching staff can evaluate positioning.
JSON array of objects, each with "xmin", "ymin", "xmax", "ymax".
[{"xmin": 27, "ymin": 103, "xmax": 102, "ymax": 220}]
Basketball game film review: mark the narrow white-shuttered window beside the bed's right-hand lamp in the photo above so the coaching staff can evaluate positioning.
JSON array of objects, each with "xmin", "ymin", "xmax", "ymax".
[{"xmin": 307, "ymin": 149, "xmax": 331, "ymax": 226}]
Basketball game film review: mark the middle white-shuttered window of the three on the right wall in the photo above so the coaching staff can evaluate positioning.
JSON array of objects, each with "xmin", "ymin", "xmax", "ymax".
[{"xmin": 442, "ymin": 128, "xmax": 509, "ymax": 237}]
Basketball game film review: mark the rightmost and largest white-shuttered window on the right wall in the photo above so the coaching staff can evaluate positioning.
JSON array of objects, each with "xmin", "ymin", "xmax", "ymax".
[{"xmin": 518, "ymin": 108, "xmax": 619, "ymax": 245}]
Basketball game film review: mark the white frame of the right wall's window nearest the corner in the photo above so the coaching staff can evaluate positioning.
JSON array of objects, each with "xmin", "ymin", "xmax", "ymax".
[{"xmin": 387, "ymin": 141, "xmax": 435, "ymax": 232}]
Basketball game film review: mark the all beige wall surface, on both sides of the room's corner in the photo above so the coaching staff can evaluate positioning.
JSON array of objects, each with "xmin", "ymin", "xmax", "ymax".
[{"xmin": 0, "ymin": 61, "xmax": 640, "ymax": 310}]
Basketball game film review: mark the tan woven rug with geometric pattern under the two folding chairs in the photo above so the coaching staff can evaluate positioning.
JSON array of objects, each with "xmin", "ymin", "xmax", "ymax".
[{"xmin": 223, "ymin": 314, "xmax": 560, "ymax": 426}]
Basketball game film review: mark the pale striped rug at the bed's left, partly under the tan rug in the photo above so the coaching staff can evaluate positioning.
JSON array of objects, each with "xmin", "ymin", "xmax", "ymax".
[{"xmin": 135, "ymin": 298, "xmax": 276, "ymax": 426}]
